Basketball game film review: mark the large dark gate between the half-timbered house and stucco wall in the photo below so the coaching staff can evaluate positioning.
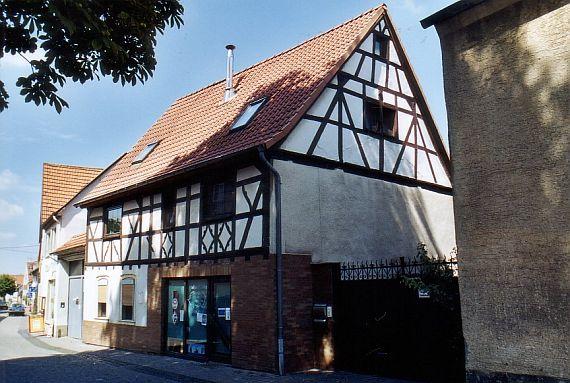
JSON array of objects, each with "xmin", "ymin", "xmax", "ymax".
[{"xmin": 334, "ymin": 259, "xmax": 464, "ymax": 383}]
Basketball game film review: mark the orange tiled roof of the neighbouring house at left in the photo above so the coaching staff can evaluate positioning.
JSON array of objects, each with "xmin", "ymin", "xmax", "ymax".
[{"xmin": 40, "ymin": 163, "xmax": 103, "ymax": 225}]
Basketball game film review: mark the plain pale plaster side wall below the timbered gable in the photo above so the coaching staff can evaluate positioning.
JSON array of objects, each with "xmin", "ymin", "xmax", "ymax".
[{"xmin": 271, "ymin": 160, "xmax": 455, "ymax": 263}]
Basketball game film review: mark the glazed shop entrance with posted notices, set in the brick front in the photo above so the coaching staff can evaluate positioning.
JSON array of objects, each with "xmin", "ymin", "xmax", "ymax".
[{"xmin": 165, "ymin": 277, "xmax": 231, "ymax": 362}]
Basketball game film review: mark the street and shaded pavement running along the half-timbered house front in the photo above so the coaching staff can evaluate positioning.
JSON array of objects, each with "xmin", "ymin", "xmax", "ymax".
[{"xmin": 0, "ymin": 314, "xmax": 418, "ymax": 383}]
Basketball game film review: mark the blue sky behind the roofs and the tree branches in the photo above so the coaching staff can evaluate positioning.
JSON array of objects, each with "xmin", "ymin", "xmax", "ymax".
[{"xmin": 0, "ymin": 0, "xmax": 454, "ymax": 274}]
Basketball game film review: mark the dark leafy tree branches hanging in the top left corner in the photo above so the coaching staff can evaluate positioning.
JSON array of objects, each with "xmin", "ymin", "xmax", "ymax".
[{"xmin": 0, "ymin": 0, "xmax": 184, "ymax": 113}]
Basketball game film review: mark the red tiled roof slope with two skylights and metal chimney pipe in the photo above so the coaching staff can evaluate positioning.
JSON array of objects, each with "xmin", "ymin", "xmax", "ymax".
[{"xmin": 80, "ymin": 5, "xmax": 386, "ymax": 205}]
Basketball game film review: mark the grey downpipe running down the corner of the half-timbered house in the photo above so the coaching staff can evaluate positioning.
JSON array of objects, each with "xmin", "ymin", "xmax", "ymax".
[{"xmin": 258, "ymin": 146, "xmax": 285, "ymax": 375}]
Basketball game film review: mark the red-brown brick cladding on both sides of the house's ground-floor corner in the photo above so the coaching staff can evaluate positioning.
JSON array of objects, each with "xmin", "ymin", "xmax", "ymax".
[{"xmin": 83, "ymin": 255, "xmax": 314, "ymax": 372}]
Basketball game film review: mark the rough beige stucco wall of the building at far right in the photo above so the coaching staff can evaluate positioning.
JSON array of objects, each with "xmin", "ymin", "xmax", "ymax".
[{"xmin": 438, "ymin": 0, "xmax": 570, "ymax": 381}]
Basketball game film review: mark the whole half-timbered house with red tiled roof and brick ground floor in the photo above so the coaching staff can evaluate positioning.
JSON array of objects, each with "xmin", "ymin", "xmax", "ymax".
[{"xmin": 80, "ymin": 6, "xmax": 454, "ymax": 371}]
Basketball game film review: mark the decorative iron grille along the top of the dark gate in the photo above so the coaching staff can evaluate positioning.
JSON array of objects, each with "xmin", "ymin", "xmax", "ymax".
[{"xmin": 340, "ymin": 257, "xmax": 457, "ymax": 281}]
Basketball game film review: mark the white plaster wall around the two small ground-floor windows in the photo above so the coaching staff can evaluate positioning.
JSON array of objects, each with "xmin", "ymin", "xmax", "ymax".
[{"xmin": 83, "ymin": 265, "xmax": 148, "ymax": 326}]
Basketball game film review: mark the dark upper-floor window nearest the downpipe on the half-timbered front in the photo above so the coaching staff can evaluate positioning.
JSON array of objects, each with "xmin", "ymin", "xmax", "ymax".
[{"xmin": 203, "ymin": 179, "xmax": 235, "ymax": 220}]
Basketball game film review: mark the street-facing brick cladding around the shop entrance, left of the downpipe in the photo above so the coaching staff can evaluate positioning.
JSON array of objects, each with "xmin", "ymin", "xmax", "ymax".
[{"xmin": 83, "ymin": 256, "xmax": 277, "ymax": 371}]
